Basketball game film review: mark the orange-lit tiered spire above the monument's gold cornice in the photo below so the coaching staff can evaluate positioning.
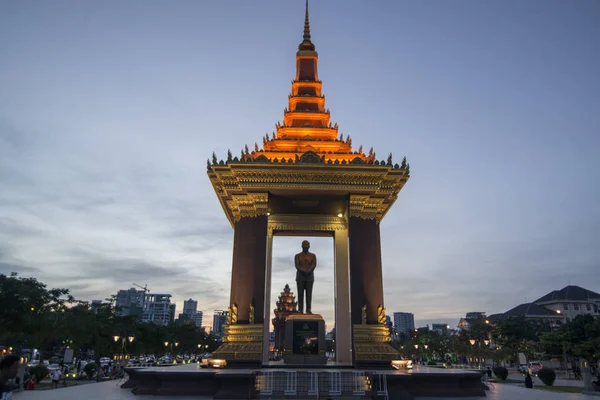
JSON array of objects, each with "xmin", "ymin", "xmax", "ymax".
[{"xmin": 242, "ymin": 0, "xmax": 375, "ymax": 164}]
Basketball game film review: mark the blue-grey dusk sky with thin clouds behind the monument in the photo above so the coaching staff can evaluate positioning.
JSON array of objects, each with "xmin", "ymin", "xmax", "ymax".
[{"xmin": 0, "ymin": 0, "xmax": 600, "ymax": 328}]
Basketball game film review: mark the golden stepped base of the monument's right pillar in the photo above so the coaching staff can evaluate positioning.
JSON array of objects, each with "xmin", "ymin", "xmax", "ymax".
[{"xmin": 353, "ymin": 324, "xmax": 400, "ymax": 368}]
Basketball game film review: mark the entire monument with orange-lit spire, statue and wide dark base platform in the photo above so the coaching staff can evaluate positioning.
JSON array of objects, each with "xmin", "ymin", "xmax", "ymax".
[{"xmin": 122, "ymin": 4, "xmax": 485, "ymax": 399}]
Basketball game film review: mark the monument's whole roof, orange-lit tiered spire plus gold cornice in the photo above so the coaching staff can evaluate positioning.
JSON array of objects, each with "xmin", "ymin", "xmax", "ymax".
[{"xmin": 207, "ymin": 1, "xmax": 410, "ymax": 227}]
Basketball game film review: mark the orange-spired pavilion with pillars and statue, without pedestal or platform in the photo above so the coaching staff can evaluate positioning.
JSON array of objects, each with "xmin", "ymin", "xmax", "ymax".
[{"xmin": 207, "ymin": 0, "xmax": 410, "ymax": 366}]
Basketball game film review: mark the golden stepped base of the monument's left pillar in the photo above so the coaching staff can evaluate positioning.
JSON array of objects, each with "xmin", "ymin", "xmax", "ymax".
[{"xmin": 212, "ymin": 324, "xmax": 264, "ymax": 368}]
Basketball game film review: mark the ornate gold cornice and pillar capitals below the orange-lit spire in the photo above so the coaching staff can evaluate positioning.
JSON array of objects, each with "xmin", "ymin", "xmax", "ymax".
[{"xmin": 208, "ymin": 162, "xmax": 409, "ymax": 225}]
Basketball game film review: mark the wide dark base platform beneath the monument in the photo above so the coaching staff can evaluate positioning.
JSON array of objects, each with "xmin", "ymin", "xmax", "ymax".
[{"xmin": 121, "ymin": 364, "xmax": 485, "ymax": 400}]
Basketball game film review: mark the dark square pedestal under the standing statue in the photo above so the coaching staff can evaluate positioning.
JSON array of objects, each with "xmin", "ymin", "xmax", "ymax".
[{"xmin": 283, "ymin": 314, "xmax": 327, "ymax": 366}]
